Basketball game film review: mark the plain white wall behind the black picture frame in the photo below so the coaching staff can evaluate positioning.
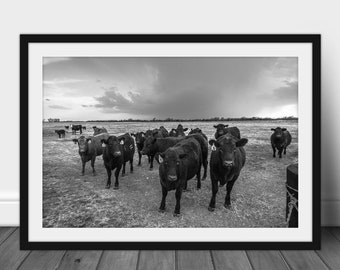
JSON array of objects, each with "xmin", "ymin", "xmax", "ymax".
[{"xmin": 0, "ymin": 0, "xmax": 340, "ymax": 225}]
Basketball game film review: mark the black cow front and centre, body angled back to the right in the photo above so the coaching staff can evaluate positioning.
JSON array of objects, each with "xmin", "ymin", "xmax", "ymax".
[{"xmin": 159, "ymin": 138, "xmax": 202, "ymax": 216}]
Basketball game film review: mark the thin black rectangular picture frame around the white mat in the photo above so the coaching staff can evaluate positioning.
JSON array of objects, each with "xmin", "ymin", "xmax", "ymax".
[{"xmin": 20, "ymin": 34, "xmax": 321, "ymax": 250}]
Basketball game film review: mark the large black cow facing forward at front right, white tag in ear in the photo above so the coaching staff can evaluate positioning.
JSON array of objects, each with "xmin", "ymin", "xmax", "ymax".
[{"xmin": 208, "ymin": 134, "xmax": 248, "ymax": 211}]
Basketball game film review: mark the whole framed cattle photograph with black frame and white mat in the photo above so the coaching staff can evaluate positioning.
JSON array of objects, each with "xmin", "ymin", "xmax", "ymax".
[{"xmin": 20, "ymin": 35, "xmax": 321, "ymax": 250}]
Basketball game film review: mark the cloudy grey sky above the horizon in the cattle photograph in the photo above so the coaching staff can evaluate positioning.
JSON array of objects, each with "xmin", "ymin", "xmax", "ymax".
[{"xmin": 43, "ymin": 57, "xmax": 298, "ymax": 120}]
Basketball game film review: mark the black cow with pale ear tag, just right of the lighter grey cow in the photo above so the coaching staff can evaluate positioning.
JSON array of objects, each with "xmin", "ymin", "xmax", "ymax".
[{"xmin": 102, "ymin": 133, "xmax": 135, "ymax": 189}]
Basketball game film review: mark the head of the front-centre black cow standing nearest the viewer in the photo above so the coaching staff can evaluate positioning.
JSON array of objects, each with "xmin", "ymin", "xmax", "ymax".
[{"xmin": 159, "ymin": 147, "xmax": 186, "ymax": 182}]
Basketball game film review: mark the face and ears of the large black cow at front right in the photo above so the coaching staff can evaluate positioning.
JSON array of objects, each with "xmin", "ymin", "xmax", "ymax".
[{"xmin": 209, "ymin": 134, "xmax": 248, "ymax": 168}]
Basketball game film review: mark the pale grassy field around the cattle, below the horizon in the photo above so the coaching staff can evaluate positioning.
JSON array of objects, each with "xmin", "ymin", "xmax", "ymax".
[{"xmin": 43, "ymin": 120, "xmax": 298, "ymax": 227}]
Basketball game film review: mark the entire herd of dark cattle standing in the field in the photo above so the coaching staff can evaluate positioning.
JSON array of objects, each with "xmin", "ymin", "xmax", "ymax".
[{"xmin": 56, "ymin": 124, "xmax": 292, "ymax": 216}]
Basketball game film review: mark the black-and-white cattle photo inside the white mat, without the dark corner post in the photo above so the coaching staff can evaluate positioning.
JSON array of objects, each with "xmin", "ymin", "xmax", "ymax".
[{"xmin": 42, "ymin": 57, "xmax": 299, "ymax": 228}]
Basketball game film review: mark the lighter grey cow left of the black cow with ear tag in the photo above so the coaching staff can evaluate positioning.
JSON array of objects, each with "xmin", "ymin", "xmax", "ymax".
[{"xmin": 73, "ymin": 134, "xmax": 109, "ymax": 175}]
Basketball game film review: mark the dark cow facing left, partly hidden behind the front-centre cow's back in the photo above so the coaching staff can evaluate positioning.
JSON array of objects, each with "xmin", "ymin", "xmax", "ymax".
[{"xmin": 142, "ymin": 136, "xmax": 184, "ymax": 170}]
